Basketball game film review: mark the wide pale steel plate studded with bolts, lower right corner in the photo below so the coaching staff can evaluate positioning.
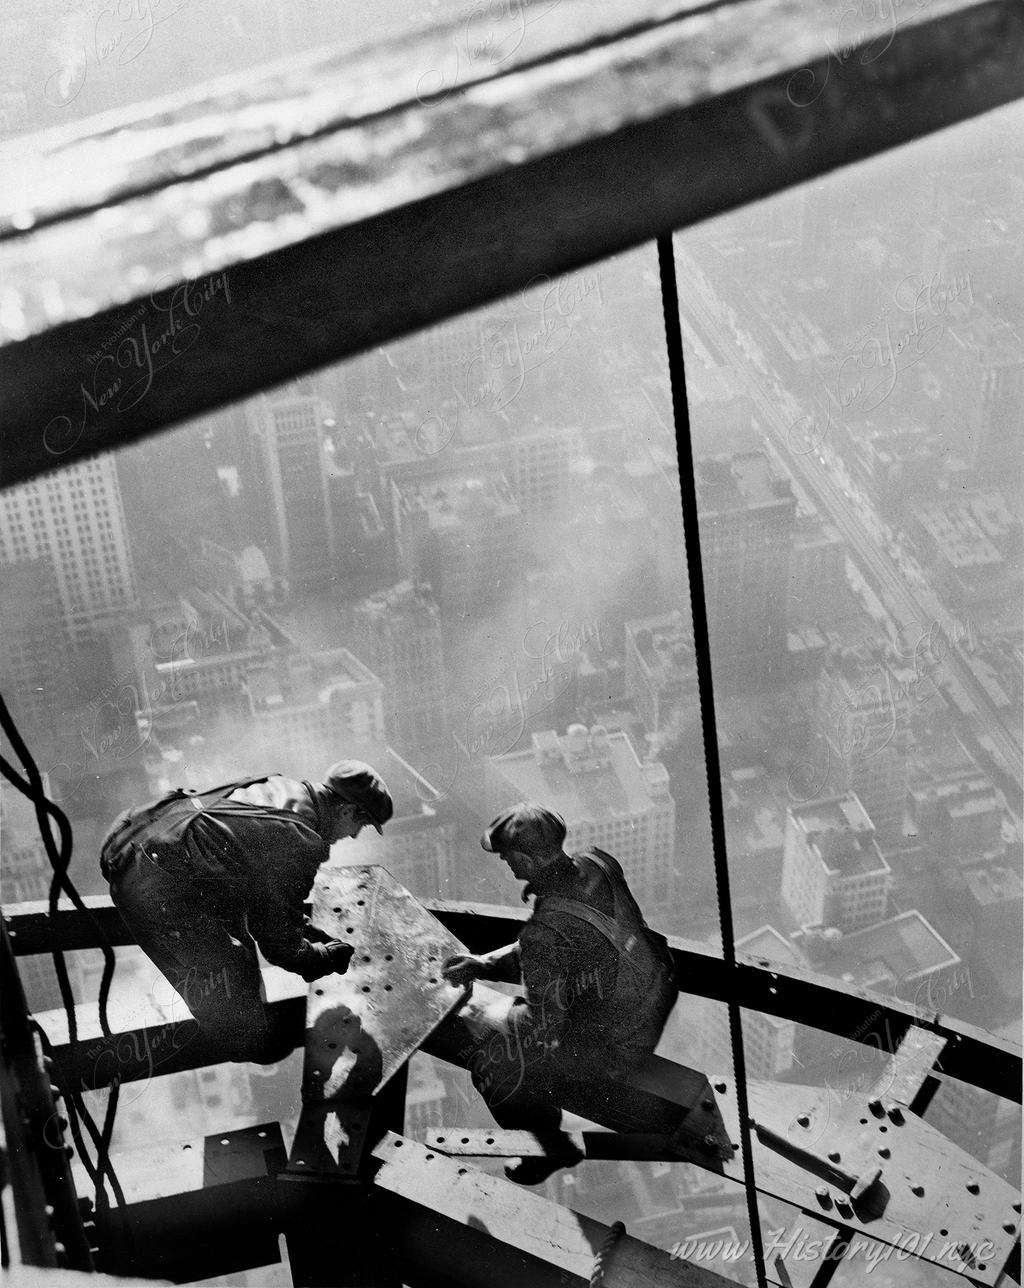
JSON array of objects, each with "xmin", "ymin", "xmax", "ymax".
[{"xmin": 712, "ymin": 1079, "xmax": 1020, "ymax": 1285}]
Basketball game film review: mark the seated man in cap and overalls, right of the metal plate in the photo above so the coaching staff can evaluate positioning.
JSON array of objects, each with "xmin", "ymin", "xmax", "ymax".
[{"xmin": 443, "ymin": 802, "xmax": 678, "ymax": 1185}]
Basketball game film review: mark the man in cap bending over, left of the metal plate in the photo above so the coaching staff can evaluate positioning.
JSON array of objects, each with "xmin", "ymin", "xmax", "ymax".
[{"xmin": 100, "ymin": 760, "xmax": 393, "ymax": 1064}]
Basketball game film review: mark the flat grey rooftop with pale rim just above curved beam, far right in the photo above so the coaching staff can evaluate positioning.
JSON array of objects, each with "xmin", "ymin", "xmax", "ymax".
[{"xmin": 823, "ymin": 909, "xmax": 960, "ymax": 988}]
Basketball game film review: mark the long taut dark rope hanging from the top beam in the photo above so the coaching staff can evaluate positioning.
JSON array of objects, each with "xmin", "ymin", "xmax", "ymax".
[{"xmin": 658, "ymin": 233, "xmax": 768, "ymax": 1288}]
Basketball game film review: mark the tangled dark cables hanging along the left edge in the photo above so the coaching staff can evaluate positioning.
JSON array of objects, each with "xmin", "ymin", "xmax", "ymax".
[{"xmin": 0, "ymin": 696, "xmax": 125, "ymax": 1211}]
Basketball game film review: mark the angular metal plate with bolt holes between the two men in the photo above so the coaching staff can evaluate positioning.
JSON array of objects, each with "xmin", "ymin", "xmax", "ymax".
[{"xmin": 303, "ymin": 867, "xmax": 466, "ymax": 1104}]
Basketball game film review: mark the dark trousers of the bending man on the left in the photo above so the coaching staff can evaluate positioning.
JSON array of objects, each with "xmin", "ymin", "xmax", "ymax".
[{"xmin": 111, "ymin": 849, "xmax": 291, "ymax": 1064}]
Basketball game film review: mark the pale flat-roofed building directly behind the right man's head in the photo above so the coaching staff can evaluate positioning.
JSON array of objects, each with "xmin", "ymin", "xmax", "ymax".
[{"xmin": 487, "ymin": 725, "xmax": 683, "ymax": 920}]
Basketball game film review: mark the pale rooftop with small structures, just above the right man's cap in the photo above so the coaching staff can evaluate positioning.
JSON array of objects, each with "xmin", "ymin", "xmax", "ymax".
[{"xmin": 489, "ymin": 725, "xmax": 668, "ymax": 827}]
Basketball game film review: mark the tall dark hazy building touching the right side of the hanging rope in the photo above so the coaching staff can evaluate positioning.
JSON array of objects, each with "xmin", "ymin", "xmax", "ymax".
[{"xmin": 696, "ymin": 452, "xmax": 796, "ymax": 689}]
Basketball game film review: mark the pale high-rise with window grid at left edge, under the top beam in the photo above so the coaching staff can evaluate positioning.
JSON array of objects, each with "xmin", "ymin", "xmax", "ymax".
[{"xmin": 0, "ymin": 455, "xmax": 138, "ymax": 641}]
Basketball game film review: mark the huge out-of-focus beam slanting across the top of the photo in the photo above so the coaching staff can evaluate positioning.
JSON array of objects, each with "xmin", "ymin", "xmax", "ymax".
[{"xmin": 0, "ymin": 0, "xmax": 1024, "ymax": 484}]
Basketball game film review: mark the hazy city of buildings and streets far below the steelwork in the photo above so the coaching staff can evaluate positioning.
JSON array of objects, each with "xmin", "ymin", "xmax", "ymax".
[{"xmin": 0, "ymin": 25, "xmax": 1024, "ymax": 1288}]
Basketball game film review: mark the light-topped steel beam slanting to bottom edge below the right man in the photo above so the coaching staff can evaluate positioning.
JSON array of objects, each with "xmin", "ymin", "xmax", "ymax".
[{"xmin": 374, "ymin": 1133, "xmax": 733, "ymax": 1288}]
